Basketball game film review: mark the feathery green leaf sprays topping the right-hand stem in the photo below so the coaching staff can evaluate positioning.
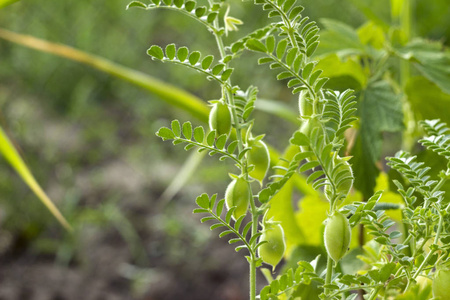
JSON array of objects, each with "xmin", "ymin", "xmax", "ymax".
[{"xmin": 236, "ymin": 0, "xmax": 328, "ymax": 101}]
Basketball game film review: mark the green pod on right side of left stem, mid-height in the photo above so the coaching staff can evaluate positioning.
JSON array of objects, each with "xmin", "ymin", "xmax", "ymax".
[{"xmin": 247, "ymin": 140, "xmax": 270, "ymax": 184}]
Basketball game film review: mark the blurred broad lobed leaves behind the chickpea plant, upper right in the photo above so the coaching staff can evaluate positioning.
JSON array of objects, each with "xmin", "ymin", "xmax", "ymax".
[{"xmin": 317, "ymin": 8, "xmax": 449, "ymax": 202}]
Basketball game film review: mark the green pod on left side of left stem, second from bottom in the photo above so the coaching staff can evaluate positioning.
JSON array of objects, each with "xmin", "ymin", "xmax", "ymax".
[{"xmin": 225, "ymin": 177, "xmax": 251, "ymax": 220}]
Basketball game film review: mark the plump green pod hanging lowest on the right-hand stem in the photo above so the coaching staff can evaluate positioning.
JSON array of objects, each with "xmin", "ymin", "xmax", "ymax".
[{"xmin": 324, "ymin": 212, "xmax": 352, "ymax": 263}]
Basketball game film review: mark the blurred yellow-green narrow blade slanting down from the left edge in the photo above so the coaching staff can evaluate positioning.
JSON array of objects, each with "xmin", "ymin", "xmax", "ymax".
[{"xmin": 0, "ymin": 127, "xmax": 72, "ymax": 231}]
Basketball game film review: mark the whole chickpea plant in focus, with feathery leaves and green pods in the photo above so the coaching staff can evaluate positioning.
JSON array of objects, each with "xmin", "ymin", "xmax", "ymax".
[{"xmin": 128, "ymin": 0, "xmax": 450, "ymax": 300}]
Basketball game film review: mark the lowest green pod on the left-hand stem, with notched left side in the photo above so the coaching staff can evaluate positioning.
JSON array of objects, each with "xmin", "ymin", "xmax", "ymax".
[{"xmin": 258, "ymin": 221, "xmax": 286, "ymax": 269}]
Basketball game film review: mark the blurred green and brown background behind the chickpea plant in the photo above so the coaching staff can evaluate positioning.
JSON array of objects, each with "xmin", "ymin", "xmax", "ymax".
[{"xmin": 0, "ymin": 0, "xmax": 450, "ymax": 300}]
